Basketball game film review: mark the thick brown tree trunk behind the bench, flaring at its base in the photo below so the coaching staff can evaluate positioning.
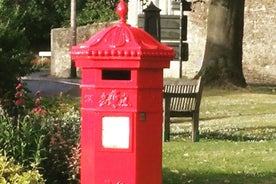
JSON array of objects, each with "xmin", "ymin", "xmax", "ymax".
[{"xmin": 198, "ymin": 0, "xmax": 246, "ymax": 87}]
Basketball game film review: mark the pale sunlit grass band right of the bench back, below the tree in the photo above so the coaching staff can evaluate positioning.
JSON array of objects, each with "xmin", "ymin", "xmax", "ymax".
[{"xmin": 200, "ymin": 93, "xmax": 276, "ymax": 119}]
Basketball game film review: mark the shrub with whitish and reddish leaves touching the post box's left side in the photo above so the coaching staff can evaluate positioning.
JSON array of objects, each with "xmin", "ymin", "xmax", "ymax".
[{"xmin": 41, "ymin": 98, "xmax": 80, "ymax": 184}]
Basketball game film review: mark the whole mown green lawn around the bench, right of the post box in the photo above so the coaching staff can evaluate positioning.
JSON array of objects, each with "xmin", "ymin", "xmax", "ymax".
[{"xmin": 163, "ymin": 86, "xmax": 276, "ymax": 184}]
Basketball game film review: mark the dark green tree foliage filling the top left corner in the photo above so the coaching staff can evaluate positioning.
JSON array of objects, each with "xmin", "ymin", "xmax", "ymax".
[{"xmin": 0, "ymin": 0, "xmax": 70, "ymax": 47}]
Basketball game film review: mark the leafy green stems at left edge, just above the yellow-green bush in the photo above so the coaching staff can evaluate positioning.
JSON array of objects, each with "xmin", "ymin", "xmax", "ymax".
[{"xmin": 0, "ymin": 110, "xmax": 50, "ymax": 167}]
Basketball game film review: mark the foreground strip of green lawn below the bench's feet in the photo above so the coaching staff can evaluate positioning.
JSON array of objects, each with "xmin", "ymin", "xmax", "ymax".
[{"xmin": 163, "ymin": 141, "xmax": 276, "ymax": 184}]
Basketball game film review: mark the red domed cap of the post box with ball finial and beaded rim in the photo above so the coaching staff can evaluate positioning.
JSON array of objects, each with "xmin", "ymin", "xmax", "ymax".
[{"xmin": 71, "ymin": 0, "xmax": 175, "ymax": 66}]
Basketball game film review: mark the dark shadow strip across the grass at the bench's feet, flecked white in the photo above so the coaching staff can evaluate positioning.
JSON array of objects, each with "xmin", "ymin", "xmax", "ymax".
[{"xmin": 171, "ymin": 126, "xmax": 276, "ymax": 141}]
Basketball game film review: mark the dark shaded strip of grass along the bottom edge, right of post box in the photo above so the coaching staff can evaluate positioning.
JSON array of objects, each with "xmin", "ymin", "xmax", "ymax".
[{"xmin": 163, "ymin": 168, "xmax": 276, "ymax": 184}]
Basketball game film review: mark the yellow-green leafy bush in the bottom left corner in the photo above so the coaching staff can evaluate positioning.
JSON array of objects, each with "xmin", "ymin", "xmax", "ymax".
[{"xmin": 0, "ymin": 155, "xmax": 45, "ymax": 184}]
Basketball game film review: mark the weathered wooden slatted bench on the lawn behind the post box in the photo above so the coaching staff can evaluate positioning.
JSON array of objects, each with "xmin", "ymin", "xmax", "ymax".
[{"xmin": 163, "ymin": 78, "xmax": 202, "ymax": 142}]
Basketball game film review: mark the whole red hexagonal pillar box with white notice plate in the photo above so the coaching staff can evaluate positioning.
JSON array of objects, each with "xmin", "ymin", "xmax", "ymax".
[{"xmin": 71, "ymin": 0, "xmax": 174, "ymax": 184}]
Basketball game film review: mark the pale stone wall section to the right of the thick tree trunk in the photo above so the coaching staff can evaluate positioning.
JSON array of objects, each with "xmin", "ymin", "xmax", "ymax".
[{"xmin": 243, "ymin": 0, "xmax": 276, "ymax": 84}]
